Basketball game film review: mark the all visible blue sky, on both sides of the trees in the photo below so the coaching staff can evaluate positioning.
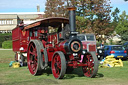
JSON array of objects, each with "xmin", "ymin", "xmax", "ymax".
[{"xmin": 0, "ymin": 0, "xmax": 128, "ymax": 14}]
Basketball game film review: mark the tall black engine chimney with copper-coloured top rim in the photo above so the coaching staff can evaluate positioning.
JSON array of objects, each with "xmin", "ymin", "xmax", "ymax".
[{"xmin": 68, "ymin": 7, "xmax": 77, "ymax": 37}]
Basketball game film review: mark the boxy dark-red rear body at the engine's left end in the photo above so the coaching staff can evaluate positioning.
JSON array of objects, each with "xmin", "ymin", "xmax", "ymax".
[{"xmin": 12, "ymin": 27, "xmax": 29, "ymax": 52}]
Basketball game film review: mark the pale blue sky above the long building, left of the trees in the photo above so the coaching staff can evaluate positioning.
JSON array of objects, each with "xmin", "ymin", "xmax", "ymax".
[{"xmin": 0, "ymin": 0, "xmax": 46, "ymax": 13}]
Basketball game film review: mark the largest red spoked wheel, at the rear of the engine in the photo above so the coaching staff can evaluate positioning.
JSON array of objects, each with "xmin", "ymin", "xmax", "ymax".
[{"xmin": 27, "ymin": 40, "xmax": 41, "ymax": 75}]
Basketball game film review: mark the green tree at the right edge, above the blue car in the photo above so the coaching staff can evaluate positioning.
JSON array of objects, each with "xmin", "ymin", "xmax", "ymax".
[{"xmin": 115, "ymin": 11, "xmax": 128, "ymax": 41}]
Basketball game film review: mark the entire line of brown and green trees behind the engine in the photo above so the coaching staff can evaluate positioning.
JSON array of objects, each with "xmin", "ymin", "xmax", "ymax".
[{"xmin": 45, "ymin": 0, "xmax": 128, "ymax": 41}]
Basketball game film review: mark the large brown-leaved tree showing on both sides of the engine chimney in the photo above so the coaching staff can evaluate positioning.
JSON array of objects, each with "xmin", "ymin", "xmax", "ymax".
[{"xmin": 45, "ymin": 0, "xmax": 113, "ymax": 40}]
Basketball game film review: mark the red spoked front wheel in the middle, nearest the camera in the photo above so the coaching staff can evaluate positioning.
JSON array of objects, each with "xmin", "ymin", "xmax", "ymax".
[{"xmin": 51, "ymin": 51, "xmax": 66, "ymax": 79}]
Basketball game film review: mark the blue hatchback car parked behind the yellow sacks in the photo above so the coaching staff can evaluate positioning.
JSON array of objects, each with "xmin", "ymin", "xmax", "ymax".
[{"xmin": 104, "ymin": 45, "xmax": 127, "ymax": 59}]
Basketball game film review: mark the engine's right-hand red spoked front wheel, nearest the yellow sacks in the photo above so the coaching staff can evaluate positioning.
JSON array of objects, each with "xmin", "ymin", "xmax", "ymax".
[{"xmin": 82, "ymin": 52, "xmax": 98, "ymax": 78}]
